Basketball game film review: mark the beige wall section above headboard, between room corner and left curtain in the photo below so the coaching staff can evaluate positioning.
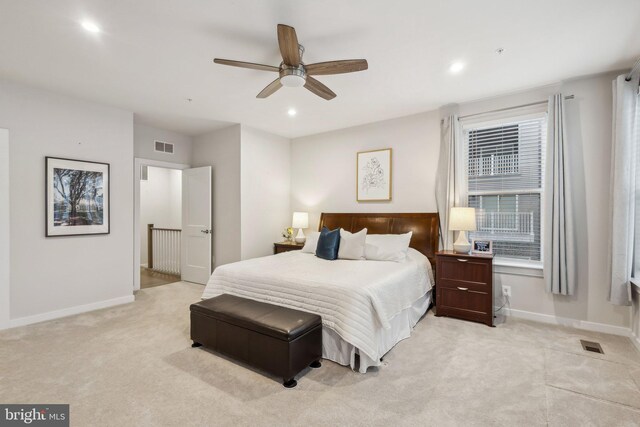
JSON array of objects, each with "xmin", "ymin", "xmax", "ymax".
[{"xmin": 291, "ymin": 112, "xmax": 440, "ymax": 230}]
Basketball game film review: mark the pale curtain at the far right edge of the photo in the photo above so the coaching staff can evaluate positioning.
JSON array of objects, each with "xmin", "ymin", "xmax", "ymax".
[{"xmin": 609, "ymin": 75, "xmax": 640, "ymax": 305}]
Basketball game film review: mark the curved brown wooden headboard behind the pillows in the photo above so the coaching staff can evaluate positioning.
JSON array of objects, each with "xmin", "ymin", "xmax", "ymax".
[{"xmin": 318, "ymin": 213, "xmax": 439, "ymax": 265}]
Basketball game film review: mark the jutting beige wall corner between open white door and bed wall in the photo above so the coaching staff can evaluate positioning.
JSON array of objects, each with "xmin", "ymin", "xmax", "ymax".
[{"xmin": 191, "ymin": 125, "xmax": 291, "ymax": 267}]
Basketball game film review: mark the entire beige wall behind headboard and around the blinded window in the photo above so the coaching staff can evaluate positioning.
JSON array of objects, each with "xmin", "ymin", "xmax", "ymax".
[{"xmin": 291, "ymin": 73, "xmax": 630, "ymax": 328}]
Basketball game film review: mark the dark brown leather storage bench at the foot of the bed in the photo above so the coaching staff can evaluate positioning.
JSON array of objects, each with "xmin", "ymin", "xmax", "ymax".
[{"xmin": 191, "ymin": 294, "xmax": 322, "ymax": 388}]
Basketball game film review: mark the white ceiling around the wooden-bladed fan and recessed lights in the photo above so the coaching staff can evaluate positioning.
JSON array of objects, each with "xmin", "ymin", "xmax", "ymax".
[{"xmin": 0, "ymin": 0, "xmax": 640, "ymax": 137}]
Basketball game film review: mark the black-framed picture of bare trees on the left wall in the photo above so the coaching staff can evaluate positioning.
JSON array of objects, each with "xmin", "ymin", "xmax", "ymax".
[{"xmin": 45, "ymin": 157, "xmax": 110, "ymax": 237}]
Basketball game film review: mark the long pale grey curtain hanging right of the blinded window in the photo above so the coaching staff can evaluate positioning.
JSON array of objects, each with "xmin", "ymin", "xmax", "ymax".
[{"xmin": 543, "ymin": 94, "xmax": 576, "ymax": 295}]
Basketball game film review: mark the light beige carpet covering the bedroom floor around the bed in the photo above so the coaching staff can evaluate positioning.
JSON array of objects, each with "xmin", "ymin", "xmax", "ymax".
[{"xmin": 0, "ymin": 283, "xmax": 640, "ymax": 426}]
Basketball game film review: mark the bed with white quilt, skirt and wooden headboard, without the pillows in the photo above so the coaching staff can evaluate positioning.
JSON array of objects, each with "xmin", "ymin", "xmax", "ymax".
[{"xmin": 202, "ymin": 213, "xmax": 438, "ymax": 373}]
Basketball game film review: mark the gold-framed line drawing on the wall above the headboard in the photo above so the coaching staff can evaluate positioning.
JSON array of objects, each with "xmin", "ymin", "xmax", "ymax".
[{"xmin": 356, "ymin": 148, "xmax": 391, "ymax": 202}]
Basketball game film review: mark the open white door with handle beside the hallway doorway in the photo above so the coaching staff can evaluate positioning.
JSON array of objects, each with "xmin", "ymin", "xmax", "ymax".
[{"xmin": 180, "ymin": 166, "xmax": 212, "ymax": 284}]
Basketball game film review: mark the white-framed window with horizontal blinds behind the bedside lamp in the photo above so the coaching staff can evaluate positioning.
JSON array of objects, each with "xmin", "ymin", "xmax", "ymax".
[{"xmin": 463, "ymin": 113, "xmax": 547, "ymax": 261}]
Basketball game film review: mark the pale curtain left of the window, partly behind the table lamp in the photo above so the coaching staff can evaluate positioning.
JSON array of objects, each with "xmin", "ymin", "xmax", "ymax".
[{"xmin": 436, "ymin": 114, "xmax": 466, "ymax": 250}]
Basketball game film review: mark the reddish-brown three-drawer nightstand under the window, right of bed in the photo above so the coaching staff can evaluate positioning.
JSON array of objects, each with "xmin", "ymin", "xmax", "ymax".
[{"xmin": 436, "ymin": 251, "xmax": 493, "ymax": 326}]
